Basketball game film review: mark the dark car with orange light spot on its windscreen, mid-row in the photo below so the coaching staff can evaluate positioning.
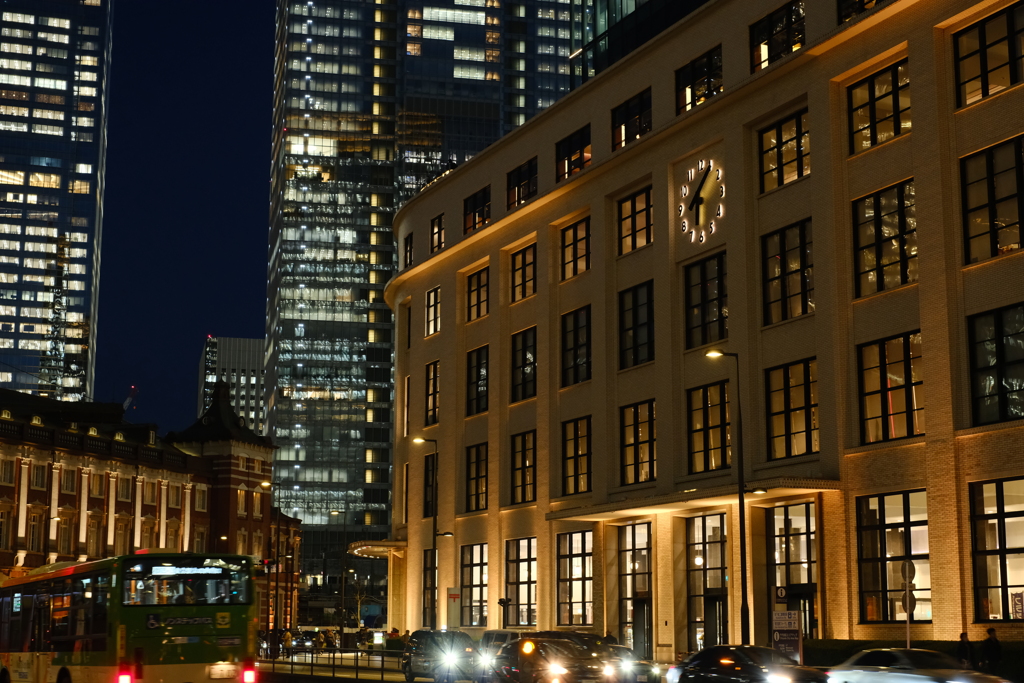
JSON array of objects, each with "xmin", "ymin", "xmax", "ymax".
[{"xmin": 493, "ymin": 634, "xmax": 615, "ymax": 683}]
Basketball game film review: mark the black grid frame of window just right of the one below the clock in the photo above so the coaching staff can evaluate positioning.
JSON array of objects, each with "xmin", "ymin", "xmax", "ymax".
[{"xmin": 761, "ymin": 218, "xmax": 814, "ymax": 326}]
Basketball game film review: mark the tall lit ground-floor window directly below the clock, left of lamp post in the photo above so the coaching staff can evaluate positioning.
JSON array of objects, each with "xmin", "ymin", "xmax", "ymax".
[{"xmin": 686, "ymin": 514, "xmax": 729, "ymax": 650}]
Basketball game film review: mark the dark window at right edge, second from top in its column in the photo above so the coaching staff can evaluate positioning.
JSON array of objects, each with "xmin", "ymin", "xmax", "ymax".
[{"xmin": 961, "ymin": 136, "xmax": 1024, "ymax": 263}]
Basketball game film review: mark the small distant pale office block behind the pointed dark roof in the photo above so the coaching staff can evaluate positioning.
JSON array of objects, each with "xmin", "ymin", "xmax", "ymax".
[{"xmin": 196, "ymin": 335, "xmax": 266, "ymax": 434}]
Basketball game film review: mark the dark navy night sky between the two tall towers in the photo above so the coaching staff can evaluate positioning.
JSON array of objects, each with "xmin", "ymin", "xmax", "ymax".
[{"xmin": 94, "ymin": 0, "xmax": 274, "ymax": 433}]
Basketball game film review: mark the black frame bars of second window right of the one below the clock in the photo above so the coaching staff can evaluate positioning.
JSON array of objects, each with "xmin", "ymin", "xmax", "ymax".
[{"xmin": 851, "ymin": 178, "xmax": 918, "ymax": 298}]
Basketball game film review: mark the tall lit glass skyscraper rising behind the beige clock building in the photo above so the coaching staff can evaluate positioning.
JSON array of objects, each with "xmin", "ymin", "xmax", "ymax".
[{"xmin": 265, "ymin": 0, "xmax": 569, "ymax": 585}]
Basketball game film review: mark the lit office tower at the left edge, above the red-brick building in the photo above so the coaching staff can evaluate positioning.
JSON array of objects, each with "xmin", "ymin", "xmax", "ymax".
[{"xmin": 0, "ymin": 0, "xmax": 112, "ymax": 400}]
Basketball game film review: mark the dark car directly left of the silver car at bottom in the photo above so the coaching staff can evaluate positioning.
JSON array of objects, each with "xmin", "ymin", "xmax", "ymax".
[{"xmin": 679, "ymin": 645, "xmax": 828, "ymax": 683}]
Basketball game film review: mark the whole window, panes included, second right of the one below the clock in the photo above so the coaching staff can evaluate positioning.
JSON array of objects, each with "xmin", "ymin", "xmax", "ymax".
[{"xmin": 853, "ymin": 180, "xmax": 918, "ymax": 297}]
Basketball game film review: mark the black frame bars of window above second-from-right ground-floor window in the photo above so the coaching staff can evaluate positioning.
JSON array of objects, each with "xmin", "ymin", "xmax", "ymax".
[{"xmin": 857, "ymin": 330, "xmax": 925, "ymax": 444}]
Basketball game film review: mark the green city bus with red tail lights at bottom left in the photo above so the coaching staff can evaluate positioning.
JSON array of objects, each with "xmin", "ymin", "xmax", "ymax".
[{"xmin": 0, "ymin": 551, "xmax": 257, "ymax": 683}]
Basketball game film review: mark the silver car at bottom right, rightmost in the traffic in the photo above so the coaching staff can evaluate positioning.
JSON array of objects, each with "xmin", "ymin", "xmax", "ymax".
[{"xmin": 828, "ymin": 649, "xmax": 1006, "ymax": 683}]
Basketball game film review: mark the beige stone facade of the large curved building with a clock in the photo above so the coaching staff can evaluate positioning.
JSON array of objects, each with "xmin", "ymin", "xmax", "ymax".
[{"xmin": 386, "ymin": 0, "xmax": 1024, "ymax": 659}]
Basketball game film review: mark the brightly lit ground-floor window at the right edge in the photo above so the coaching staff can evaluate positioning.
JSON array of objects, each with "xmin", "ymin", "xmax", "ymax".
[{"xmin": 971, "ymin": 478, "xmax": 1024, "ymax": 622}]
